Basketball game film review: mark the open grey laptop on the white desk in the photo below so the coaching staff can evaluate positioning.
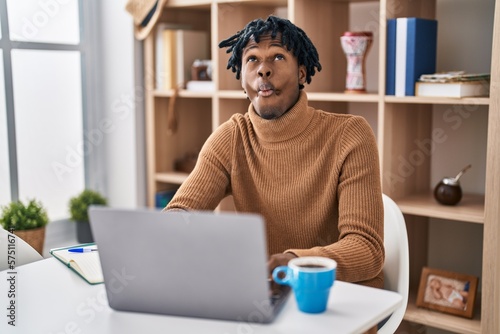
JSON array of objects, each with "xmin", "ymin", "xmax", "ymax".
[{"xmin": 89, "ymin": 207, "xmax": 289, "ymax": 323}]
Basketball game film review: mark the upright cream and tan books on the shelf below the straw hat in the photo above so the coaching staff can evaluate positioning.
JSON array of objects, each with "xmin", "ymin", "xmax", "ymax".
[{"xmin": 155, "ymin": 24, "xmax": 210, "ymax": 90}]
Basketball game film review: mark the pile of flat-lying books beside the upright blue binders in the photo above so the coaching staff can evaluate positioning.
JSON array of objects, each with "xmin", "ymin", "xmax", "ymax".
[{"xmin": 415, "ymin": 71, "xmax": 490, "ymax": 98}]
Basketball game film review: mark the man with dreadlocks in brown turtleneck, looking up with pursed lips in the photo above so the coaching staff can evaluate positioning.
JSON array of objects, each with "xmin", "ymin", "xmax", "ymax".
[{"xmin": 165, "ymin": 16, "xmax": 384, "ymax": 287}]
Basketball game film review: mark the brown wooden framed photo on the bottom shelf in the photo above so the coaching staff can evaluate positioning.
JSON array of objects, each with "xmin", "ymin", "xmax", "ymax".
[{"xmin": 417, "ymin": 267, "xmax": 478, "ymax": 318}]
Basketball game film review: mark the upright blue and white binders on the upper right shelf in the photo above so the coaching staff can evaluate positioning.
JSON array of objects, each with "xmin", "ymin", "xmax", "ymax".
[{"xmin": 386, "ymin": 17, "xmax": 437, "ymax": 96}]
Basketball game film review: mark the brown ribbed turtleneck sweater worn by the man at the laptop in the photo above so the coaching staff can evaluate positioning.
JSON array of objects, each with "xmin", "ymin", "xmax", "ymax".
[{"xmin": 166, "ymin": 91, "xmax": 384, "ymax": 287}]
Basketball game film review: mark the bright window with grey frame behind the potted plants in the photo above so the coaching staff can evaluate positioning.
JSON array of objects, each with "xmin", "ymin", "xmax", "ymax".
[{"xmin": 0, "ymin": 0, "xmax": 95, "ymax": 220}]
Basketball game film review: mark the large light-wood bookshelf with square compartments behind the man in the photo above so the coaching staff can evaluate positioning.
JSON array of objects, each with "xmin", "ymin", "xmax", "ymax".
[{"xmin": 144, "ymin": 0, "xmax": 500, "ymax": 334}]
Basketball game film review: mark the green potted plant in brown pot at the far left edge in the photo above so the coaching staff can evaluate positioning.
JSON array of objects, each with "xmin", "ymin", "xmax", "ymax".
[{"xmin": 0, "ymin": 199, "xmax": 49, "ymax": 254}]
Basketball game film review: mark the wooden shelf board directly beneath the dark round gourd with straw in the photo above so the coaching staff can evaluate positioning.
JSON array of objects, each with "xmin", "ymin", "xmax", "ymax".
[{"xmin": 396, "ymin": 193, "xmax": 484, "ymax": 224}]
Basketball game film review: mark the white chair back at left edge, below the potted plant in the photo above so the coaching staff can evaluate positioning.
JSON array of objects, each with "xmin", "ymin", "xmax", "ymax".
[{"xmin": 0, "ymin": 227, "xmax": 43, "ymax": 271}]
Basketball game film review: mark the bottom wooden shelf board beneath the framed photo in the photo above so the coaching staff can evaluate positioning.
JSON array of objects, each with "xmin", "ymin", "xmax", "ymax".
[{"xmin": 404, "ymin": 296, "xmax": 481, "ymax": 334}]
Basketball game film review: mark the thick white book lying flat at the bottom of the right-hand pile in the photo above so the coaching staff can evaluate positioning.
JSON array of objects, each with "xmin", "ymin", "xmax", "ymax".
[{"xmin": 415, "ymin": 81, "xmax": 489, "ymax": 98}]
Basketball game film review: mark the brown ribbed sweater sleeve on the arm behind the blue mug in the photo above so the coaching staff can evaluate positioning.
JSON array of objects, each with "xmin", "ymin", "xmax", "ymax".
[{"xmin": 288, "ymin": 117, "xmax": 385, "ymax": 287}]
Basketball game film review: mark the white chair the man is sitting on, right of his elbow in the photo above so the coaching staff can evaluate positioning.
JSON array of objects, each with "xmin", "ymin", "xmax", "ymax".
[{"xmin": 378, "ymin": 194, "xmax": 410, "ymax": 334}]
